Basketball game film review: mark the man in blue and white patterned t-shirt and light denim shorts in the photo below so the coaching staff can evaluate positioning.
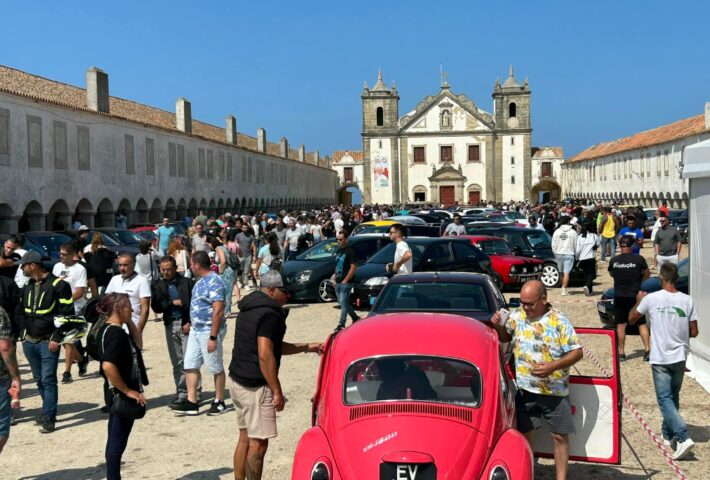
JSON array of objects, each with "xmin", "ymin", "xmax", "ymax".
[{"xmin": 173, "ymin": 251, "xmax": 231, "ymax": 415}]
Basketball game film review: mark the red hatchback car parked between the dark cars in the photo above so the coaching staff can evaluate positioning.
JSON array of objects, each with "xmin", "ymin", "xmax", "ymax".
[{"xmin": 460, "ymin": 235, "xmax": 545, "ymax": 287}]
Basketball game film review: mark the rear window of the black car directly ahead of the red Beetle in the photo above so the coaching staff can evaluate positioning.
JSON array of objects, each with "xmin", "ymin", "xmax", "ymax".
[{"xmin": 375, "ymin": 282, "xmax": 489, "ymax": 313}]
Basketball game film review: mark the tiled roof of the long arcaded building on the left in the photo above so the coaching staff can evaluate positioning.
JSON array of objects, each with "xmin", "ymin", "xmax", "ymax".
[{"xmin": 0, "ymin": 65, "xmax": 322, "ymax": 164}]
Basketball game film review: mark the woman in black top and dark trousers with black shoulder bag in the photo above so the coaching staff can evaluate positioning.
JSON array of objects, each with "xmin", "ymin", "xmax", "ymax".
[{"xmin": 96, "ymin": 293, "xmax": 147, "ymax": 480}]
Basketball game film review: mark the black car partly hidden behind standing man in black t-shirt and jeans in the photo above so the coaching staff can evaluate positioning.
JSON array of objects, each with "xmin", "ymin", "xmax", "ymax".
[{"xmin": 283, "ymin": 235, "xmax": 390, "ymax": 302}]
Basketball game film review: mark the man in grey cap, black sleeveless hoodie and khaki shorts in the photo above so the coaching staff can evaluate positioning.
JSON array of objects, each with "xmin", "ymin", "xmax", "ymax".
[{"xmin": 229, "ymin": 270, "xmax": 321, "ymax": 480}]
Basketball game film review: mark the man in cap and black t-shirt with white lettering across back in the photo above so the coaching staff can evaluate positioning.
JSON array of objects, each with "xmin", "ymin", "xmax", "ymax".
[{"xmin": 609, "ymin": 237, "xmax": 650, "ymax": 361}]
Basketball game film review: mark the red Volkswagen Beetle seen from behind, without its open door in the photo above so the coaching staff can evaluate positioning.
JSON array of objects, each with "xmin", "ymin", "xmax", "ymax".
[{"xmin": 291, "ymin": 313, "xmax": 533, "ymax": 480}]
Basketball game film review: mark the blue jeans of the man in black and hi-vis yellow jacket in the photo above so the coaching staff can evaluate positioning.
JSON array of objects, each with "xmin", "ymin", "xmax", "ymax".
[{"xmin": 22, "ymin": 340, "xmax": 59, "ymax": 418}]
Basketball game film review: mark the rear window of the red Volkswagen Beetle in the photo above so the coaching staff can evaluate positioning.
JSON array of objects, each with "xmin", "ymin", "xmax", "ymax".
[{"xmin": 343, "ymin": 355, "xmax": 482, "ymax": 407}]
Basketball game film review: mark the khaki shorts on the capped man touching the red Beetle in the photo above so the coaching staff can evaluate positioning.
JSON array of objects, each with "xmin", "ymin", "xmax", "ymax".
[{"xmin": 229, "ymin": 378, "xmax": 277, "ymax": 439}]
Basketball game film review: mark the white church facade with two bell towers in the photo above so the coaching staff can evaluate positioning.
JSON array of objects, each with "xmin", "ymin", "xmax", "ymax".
[{"xmin": 361, "ymin": 67, "xmax": 554, "ymax": 205}]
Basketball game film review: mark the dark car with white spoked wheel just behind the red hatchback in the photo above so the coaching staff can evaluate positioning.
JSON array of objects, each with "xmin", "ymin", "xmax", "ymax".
[{"xmin": 472, "ymin": 227, "xmax": 596, "ymax": 287}]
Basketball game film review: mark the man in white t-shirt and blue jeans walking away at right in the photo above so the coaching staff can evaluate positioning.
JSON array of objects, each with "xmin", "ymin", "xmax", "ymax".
[{"xmin": 629, "ymin": 263, "xmax": 698, "ymax": 460}]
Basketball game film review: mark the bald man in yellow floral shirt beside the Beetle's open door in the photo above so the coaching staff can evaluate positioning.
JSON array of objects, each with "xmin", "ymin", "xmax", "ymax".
[{"xmin": 491, "ymin": 280, "xmax": 582, "ymax": 480}]
